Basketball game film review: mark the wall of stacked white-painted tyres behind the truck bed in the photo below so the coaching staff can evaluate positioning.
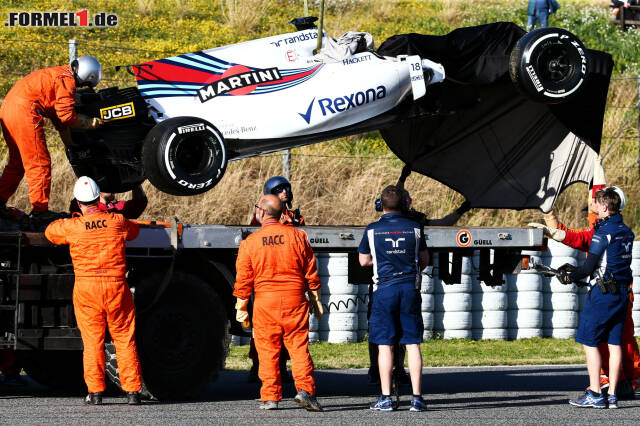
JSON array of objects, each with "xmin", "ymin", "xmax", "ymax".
[{"xmin": 232, "ymin": 240, "xmax": 640, "ymax": 344}]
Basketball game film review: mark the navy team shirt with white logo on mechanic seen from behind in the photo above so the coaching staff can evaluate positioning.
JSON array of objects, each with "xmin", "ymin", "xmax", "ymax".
[{"xmin": 358, "ymin": 213, "xmax": 427, "ymax": 285}]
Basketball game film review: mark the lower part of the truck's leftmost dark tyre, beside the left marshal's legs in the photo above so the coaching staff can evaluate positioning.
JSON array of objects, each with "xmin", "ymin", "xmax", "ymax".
[{"xmin": 16, "ymin": 351, "xmax": 87, "ymax": 393}]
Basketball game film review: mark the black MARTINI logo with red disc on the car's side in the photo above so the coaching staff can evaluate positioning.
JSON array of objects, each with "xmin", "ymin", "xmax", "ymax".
[{"xmin": 198, "ymin": 65, "xmax": 282, "ymax": 103}]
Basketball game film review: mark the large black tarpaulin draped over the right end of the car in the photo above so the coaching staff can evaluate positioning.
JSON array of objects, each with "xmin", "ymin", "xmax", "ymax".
[{"xmin": 378, "ymin": 22, "xmax": 613, "ymax": 211}]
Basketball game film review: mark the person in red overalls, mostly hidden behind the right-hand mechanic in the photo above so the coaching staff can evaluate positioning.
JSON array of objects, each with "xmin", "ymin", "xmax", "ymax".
[{"xmin": 529, "ymin": 186, "xmax": 640, "ymax": 399}]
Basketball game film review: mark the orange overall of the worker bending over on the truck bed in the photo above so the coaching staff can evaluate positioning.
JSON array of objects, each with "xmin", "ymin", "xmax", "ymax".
[{"xmin": 0, "ymin": 65, "xmax": 78, "ymax": 212}]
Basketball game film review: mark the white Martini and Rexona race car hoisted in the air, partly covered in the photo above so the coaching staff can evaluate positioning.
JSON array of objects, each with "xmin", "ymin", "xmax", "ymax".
[{"xmin": 67, "ymin": 20, "xmax": 611, "ymax": 208}]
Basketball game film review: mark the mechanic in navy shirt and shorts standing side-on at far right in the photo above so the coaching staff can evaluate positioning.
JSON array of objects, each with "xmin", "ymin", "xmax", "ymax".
[{"xmin": 558, "ymin": 187, "xmax": 635, "ymax": 408}]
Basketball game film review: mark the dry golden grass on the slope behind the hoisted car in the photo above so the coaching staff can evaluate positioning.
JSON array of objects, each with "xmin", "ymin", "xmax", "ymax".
[{"xmin": 0, "ymin": 0, "xmax": 640, "ymax": 230}]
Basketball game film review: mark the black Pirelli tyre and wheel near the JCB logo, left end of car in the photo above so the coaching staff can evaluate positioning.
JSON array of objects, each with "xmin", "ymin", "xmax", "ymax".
[{"xmin": 142, "ymin": 117, "xmax": 227, "ymax": 196}]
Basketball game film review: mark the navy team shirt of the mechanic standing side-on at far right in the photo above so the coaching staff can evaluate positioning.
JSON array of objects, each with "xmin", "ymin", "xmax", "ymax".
[{"xmin": 589, "ymin": 214, "xmax": 635, "ymax": 284}]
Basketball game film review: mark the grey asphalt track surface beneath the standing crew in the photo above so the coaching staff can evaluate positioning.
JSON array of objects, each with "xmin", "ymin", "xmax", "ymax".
[{"xmin": 0, "ymin": 365, "xmax": 640, "ymax": 426}]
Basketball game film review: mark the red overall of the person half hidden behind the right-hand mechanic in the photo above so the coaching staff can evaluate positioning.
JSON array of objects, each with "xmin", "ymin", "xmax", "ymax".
[{"xmin": 557, "ymin": 213, "xmax": 640, "ymax": 389}]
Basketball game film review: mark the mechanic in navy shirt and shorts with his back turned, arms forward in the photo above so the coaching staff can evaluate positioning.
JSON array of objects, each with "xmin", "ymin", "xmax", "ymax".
[{"xmin": 358, "ymin": 185, "xmax": 429, "ymax": 411}]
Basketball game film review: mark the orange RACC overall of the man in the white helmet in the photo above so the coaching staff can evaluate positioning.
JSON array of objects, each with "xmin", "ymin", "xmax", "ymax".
[{"xmin": 45, "ymin": 207, "xmax": 142, "ymax": 393}]
